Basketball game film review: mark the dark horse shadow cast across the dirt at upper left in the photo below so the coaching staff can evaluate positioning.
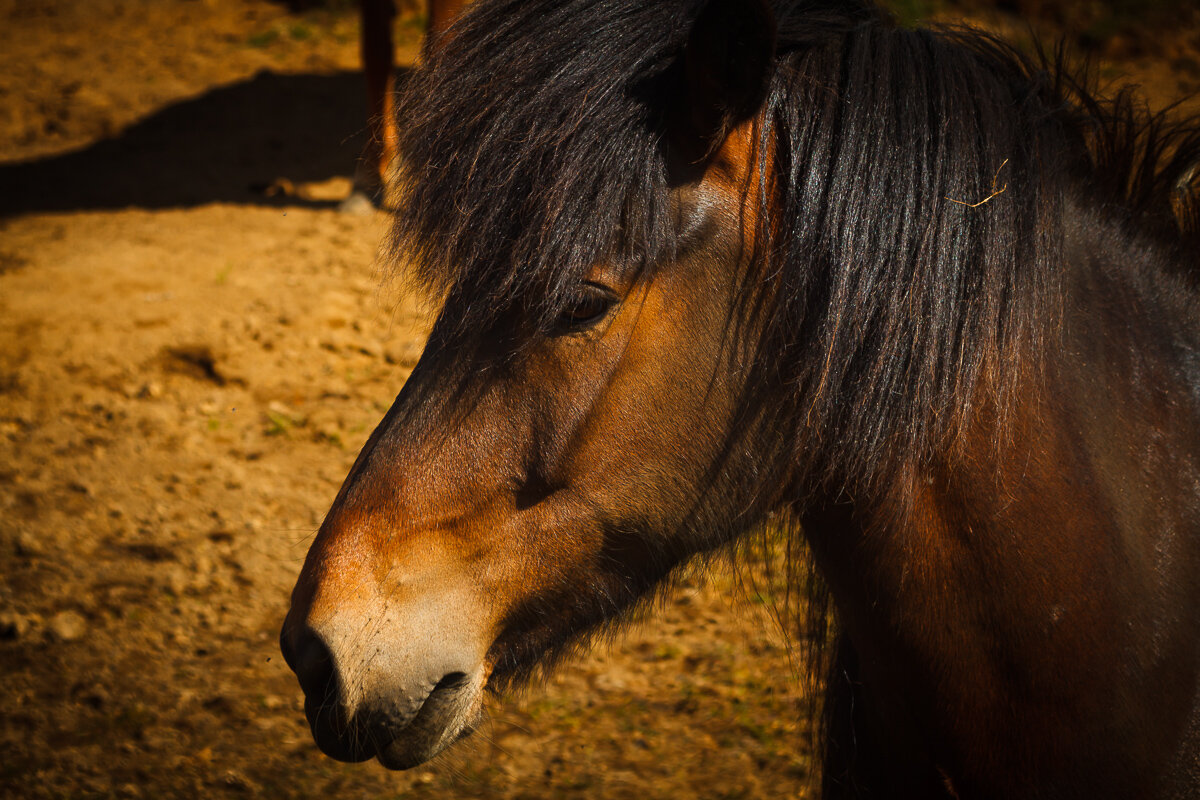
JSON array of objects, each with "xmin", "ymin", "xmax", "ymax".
[{"xmin": 0, "ymin": 72, "xmax": 412, "ymax": 216}]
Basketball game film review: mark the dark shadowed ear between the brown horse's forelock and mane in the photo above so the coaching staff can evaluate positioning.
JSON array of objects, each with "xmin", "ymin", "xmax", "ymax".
[{"xmin": 671, "ymin": 0, "xmax": 775, "ymax": 161}]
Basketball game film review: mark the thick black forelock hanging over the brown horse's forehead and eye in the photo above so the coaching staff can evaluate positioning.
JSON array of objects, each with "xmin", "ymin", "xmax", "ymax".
[{"xmin": 394, "ymin": 0, "xmax": 690, "ymax": 331}]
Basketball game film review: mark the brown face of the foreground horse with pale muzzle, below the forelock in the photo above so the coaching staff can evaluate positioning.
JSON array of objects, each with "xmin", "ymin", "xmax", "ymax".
[{"xmin": 281, "ymin": 0, "xmax": 777, "ymax": 768}]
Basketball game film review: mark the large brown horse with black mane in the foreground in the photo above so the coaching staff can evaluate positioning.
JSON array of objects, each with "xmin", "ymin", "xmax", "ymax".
[{"xmin": 281, "ymin": 0, "xmax": 1200, "ymax": 800}]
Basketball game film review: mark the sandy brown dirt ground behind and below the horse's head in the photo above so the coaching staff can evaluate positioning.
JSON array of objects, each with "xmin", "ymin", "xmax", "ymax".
[{"xmin": 0, "ymin": 0, "xmax": 1200, "ymax": 800}]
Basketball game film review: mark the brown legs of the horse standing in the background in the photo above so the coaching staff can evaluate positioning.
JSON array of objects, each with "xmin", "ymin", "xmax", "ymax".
[{"xmin": 355, "ymin": 0, "xmax": 466, "ymax": 200}]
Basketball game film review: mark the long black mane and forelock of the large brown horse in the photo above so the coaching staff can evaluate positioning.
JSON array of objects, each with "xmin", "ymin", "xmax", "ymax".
[{"xmin": 392, "ymin": 0, "xmax": 1200, "ymax": 489}]
